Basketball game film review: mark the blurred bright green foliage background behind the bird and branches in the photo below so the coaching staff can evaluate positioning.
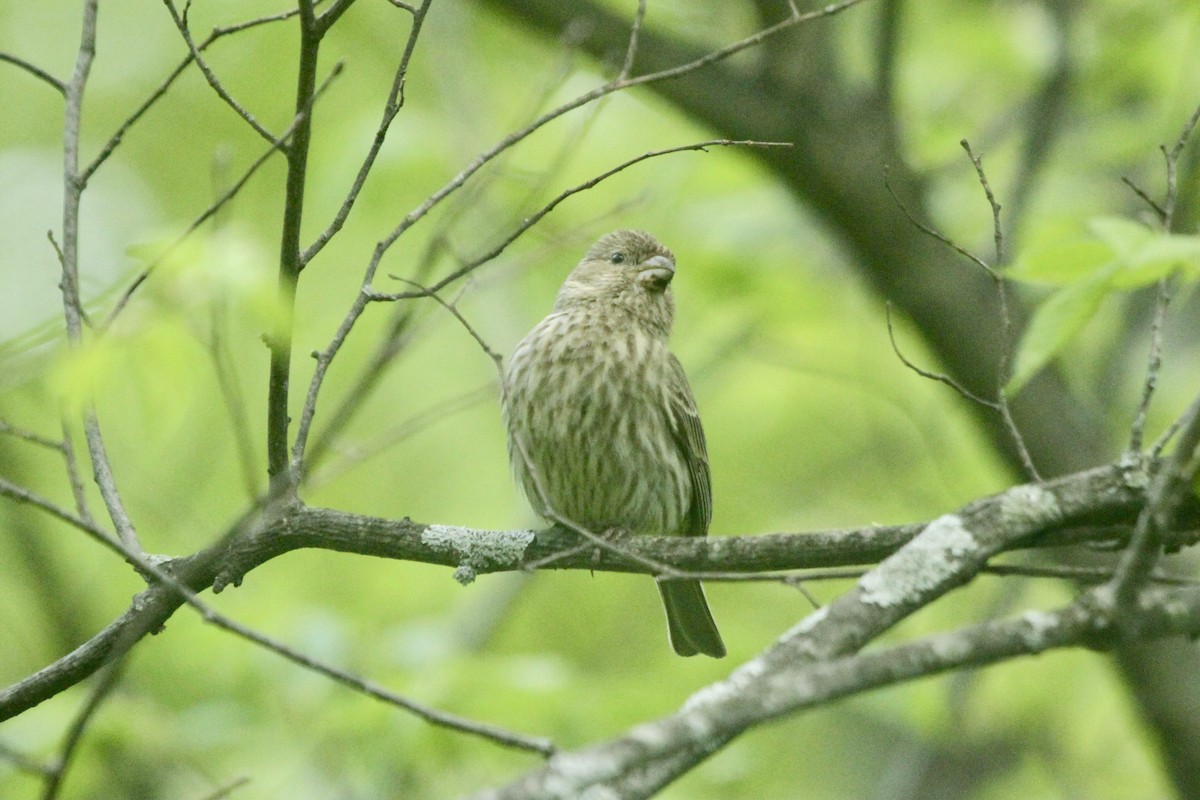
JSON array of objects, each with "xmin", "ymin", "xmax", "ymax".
[{"xmin": 0, "ymin": 0, "xmax": 1200, "ymax": 800}]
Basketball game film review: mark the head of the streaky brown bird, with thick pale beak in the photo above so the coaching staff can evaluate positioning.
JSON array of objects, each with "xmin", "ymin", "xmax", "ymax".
[{"xmin": 554, "ymin": 230, "xmax": 676, "ymax": 333}]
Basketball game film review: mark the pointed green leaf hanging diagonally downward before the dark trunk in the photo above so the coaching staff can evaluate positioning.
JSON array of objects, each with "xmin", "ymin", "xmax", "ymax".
[{"xmin": 1004, "ymin": 264, "xmax": 1120, "ymax": 395}]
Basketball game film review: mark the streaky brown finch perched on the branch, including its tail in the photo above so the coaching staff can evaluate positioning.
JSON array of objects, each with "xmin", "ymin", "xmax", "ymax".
[{"xmin": 504, "ymin": 230, "xmax": 725, "ymax": 658}]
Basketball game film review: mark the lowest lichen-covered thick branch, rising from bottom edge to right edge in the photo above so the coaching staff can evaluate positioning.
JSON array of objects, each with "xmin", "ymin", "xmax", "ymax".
[{"xmin": 465, "ymin": 588, "xmax": 1200, "ymax": 800}]
